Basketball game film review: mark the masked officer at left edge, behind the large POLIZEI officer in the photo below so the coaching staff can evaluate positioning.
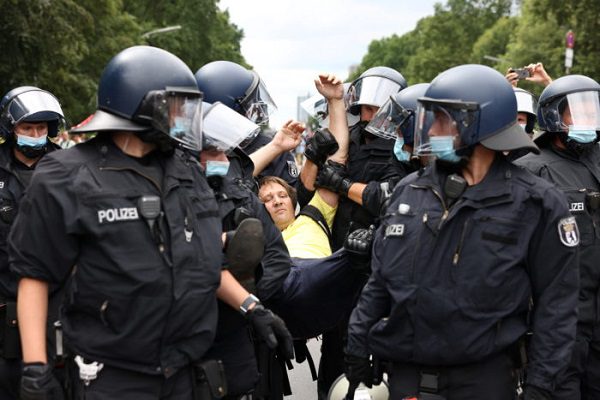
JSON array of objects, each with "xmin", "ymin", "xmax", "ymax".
[{"xmin": 0, "ymin": 86, "xmax": 64, "ymax": 399}]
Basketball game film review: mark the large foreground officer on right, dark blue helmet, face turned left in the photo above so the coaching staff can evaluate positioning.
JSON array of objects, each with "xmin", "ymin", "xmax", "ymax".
[{"xmin": 346, "ymin": 65, "xmax": 579, "ymax": 400}]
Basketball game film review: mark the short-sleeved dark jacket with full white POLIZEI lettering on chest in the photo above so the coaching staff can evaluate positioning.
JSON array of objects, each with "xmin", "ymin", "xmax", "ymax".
[{"xmin": 9, "ymin": 134, "xmax": 222, "ymax": 390}]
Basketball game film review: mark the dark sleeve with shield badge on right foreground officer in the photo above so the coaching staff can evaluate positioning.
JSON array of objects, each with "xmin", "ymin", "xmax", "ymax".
[{"xmin": 527, "ymin": 188, "xmax": 579, "ymax": 390}]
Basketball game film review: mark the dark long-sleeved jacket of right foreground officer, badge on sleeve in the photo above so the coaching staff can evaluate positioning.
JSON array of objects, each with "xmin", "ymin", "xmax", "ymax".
[{"xmin": 347, "ymin": 154, "xmax": 578, "ymax": 399}]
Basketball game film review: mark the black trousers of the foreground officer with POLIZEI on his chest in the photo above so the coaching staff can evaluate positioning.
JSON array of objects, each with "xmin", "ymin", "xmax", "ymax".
[{"xmin": 70, "ymin": 364, "xmax": 194, "ymax": 400}]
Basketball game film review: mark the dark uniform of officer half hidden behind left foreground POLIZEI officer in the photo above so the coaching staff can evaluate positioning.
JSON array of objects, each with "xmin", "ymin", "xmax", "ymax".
[{"xmin": 208, "ymin": 171, "xmax": 291, "ymax": 399}]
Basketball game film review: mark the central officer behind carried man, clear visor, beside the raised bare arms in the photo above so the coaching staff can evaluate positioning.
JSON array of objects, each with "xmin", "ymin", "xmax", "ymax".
[{"xmin": 299, "ymin": 67, "xmax": 406, "ymax": 399}]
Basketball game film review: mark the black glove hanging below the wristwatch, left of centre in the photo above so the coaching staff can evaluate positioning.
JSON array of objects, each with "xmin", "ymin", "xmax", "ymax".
[{"xmin": 246, "ymin": 304, "xmax": 294, "ymax": 360}]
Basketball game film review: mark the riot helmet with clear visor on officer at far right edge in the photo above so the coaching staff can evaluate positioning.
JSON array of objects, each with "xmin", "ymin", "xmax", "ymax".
[{"xmin": 537, "ymin": 75, "xmax": 600, "ymax": 132}]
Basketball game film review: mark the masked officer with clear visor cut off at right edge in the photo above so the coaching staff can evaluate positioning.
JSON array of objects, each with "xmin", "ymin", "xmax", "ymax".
[{"xmin": 517, "ymin": 75, "xmax": 600, "ymax": 399}]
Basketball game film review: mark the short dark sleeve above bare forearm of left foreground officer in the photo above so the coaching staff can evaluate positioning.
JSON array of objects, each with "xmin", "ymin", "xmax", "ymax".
[{"xmin": 8, "ymin": 156, "xmax": 79, "ymax": 283}]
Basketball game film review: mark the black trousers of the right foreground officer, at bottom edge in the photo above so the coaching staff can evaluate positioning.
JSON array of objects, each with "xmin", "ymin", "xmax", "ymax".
[{"xmin": 388, "ymin": 353, "xmax": 516, "ymax": 400}]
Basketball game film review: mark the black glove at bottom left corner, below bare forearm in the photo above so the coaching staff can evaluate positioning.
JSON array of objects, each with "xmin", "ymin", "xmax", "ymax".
[{"xmin": 20, "ymin": 363, "xmax": 65, "ymax": 400}]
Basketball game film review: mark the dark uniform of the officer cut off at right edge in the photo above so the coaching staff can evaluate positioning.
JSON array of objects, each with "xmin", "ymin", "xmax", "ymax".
[{"xmin": 517, "ymin": 143, "xmax": 600, "ymax": 398}]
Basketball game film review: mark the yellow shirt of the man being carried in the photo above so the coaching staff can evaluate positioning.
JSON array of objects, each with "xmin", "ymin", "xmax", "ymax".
[{"xmin": 281, "ymin": 190, "xmax": 337, "ymax": 258}]
